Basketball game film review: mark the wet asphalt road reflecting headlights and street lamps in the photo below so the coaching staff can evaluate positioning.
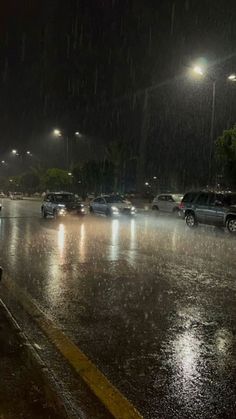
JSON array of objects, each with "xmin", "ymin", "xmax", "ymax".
[{"xmin": 0, "ymin": 200, "xmax": 236, "ymax": 419}]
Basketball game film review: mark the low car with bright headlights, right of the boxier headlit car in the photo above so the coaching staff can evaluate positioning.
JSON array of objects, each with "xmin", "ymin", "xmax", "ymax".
[{"xmin": 89, "ymin": 195, "xmax": 136, "ymax": 217}]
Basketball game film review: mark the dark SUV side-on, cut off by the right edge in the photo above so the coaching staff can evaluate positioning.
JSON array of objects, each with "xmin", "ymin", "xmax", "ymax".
[{"xmin": 179, "ymin": 191, "xmax": 236, "ymax": 234}]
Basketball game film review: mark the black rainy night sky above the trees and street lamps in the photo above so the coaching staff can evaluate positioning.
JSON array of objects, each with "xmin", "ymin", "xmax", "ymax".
[{"xmin": 0, "ymin": 0, "xmax": 236, "ymax": 186}]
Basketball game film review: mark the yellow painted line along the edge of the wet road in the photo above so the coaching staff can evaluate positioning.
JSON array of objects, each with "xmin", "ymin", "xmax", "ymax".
[{"xmin": 4, "ymin": 277, "xmax": 142, "ymax": 419}]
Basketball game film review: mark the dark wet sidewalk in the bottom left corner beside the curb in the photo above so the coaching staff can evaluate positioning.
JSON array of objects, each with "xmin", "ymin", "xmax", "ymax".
[{"xmin": 0, "ymin": 300, "xmax": 63, "ymax": 419}]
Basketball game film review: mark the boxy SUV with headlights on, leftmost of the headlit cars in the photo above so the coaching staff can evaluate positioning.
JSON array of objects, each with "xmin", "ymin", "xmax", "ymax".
[{"xmin": 41, "ymin": 192, "xmax": 86, "ymax": 218}]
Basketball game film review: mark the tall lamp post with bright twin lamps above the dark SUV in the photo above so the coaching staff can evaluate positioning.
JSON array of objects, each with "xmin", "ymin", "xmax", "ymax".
[{"xmin": 192, "ymin": 65, "xmax": 236, "ymax": 184}]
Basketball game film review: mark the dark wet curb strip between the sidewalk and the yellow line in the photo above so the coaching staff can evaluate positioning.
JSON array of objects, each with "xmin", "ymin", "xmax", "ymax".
[{"xmin": 0, "ymin": 299, "xmax": 78, "ymax": 419}]
